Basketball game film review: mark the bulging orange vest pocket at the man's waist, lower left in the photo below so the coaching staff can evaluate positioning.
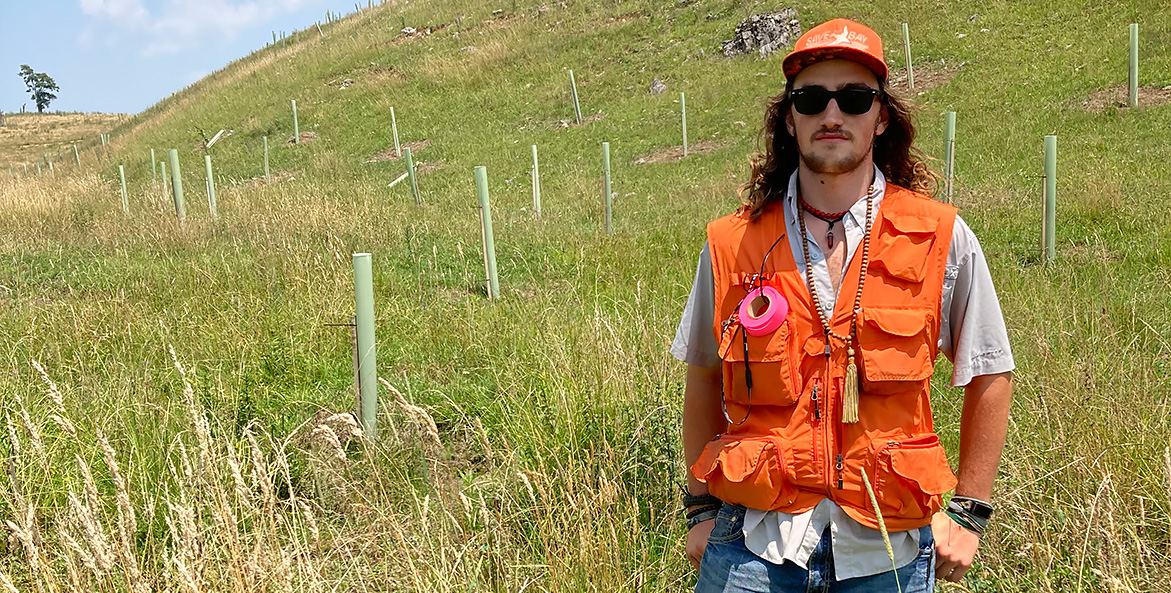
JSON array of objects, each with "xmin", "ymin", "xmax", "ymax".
[{"xmin": 691, "ymin": 436, "xmax": 797, "ymax": 511}]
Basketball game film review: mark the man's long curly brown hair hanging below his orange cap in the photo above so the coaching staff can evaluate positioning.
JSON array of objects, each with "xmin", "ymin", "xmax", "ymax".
[{"xmin": 737, "ymin": 81, "xmax": 940, "ymax": 220}]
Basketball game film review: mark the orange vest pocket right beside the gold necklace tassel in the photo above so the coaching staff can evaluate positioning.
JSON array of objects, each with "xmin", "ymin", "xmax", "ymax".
[{"xmin": 858, "ymin": 307, "xmax": 934, "ymax": 394}]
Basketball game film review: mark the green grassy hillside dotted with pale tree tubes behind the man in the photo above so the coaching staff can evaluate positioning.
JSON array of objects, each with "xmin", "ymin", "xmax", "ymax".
[{"xmin": 0, "ymin": 0, "xmax": 1171, "ymax": 592}]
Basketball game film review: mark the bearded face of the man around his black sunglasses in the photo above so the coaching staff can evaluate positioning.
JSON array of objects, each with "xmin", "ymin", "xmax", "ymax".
[{"xmin": 785, "ymin": 60, "xmax": 886, "ymax": 175}]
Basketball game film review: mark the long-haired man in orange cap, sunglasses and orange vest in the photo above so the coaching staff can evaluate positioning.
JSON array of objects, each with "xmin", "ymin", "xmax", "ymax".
[{"xmin": 672, "ymin": 19, "xmax": 1014, "ymax": 593}]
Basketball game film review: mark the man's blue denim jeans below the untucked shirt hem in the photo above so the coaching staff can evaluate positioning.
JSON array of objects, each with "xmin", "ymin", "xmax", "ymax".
[{"xmin": 696, "ymin": 504, "xmax": 936, "ymax": 593}]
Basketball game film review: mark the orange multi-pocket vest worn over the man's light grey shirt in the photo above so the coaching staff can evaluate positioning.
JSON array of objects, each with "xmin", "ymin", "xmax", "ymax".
[{"xmin": 691, "ymin": 184, "xmax": 956, "ymax": 531}]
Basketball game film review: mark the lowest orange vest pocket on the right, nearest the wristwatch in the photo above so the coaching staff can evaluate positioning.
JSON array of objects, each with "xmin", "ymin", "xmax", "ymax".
[{"xmin": 874, "ymin": 434, "xmax": 956, "ymax": 519}]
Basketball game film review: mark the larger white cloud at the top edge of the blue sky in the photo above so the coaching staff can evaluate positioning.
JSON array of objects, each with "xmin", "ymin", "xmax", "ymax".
[{"xmin": 78, "ymin": 0, "xmax": 315, "ymax": 55}]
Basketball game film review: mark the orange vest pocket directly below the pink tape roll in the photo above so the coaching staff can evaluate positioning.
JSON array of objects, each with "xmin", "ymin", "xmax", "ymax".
[{"xmin": 720, "ymin": 319, "xmax": 800, "ymax": 405}]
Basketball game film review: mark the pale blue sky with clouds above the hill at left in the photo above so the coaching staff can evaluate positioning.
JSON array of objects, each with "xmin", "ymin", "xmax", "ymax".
[{"xmin": 0, "ymin": 0, "xmax": 367, "ymax": 114}]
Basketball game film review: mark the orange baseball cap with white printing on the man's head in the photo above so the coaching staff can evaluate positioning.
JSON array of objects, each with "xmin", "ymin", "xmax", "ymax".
[{"xmin": 781, "ymin": 19, "xmax": 886, "ymax": 82}]
